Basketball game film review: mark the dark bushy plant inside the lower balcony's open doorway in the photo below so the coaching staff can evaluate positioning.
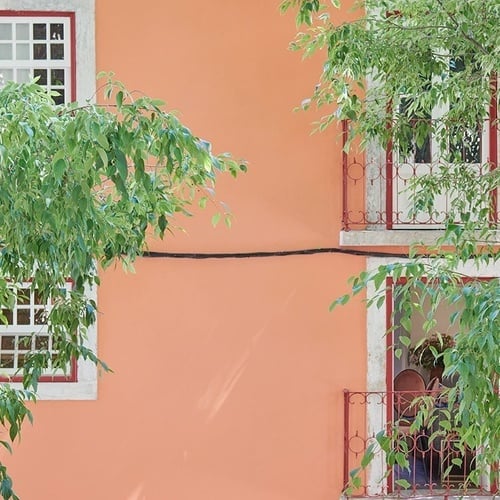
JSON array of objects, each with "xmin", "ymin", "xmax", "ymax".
[{"xmin": 409, "ymin": 333, "xmax": 455, "ymax": 380}]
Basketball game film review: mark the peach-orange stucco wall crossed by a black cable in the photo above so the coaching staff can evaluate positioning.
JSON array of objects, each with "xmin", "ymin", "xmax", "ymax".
[{"xmin": 3, "ymin": 0, "xmax": 366, "ymax": 500}]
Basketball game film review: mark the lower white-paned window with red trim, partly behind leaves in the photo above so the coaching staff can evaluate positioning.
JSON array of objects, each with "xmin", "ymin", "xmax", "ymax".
[{"xmin": 0, "ymin": 281, "xmax": 77, "ymax": 382}]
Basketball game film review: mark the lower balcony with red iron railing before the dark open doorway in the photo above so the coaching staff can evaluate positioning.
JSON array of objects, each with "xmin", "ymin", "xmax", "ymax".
[{"xmin": 343, "ymin": 390, "xmax": 498, "ymax": 498}]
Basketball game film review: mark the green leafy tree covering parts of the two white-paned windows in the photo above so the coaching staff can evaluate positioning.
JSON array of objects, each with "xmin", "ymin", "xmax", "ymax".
[{"xmin": 0, "ymin": 79, "xmax": 246, "ymax": 499}]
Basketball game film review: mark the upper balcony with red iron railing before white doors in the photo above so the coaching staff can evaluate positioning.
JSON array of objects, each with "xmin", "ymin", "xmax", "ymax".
[{"xmin": 341, "ymin": 122, "xmax": 500, "ymax": 245}]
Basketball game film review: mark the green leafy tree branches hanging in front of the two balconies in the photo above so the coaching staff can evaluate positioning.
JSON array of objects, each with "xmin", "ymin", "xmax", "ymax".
[{"xmin": 281, "ymin": 0, "xmax": 500, "ymax": 492}]
